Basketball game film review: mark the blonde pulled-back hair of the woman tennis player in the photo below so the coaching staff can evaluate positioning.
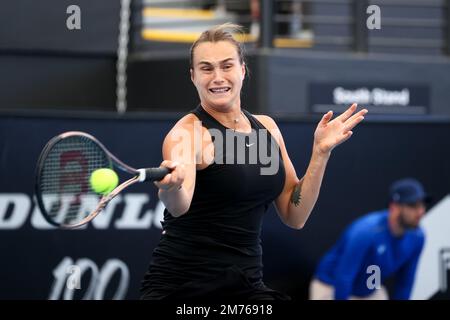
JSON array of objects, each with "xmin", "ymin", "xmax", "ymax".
[{"xmin": 190, "ymin": 22, "xmax": 245, "ymax": 68}]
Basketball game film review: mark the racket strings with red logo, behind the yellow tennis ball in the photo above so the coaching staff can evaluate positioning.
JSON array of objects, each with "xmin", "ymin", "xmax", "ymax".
[{"xmin": 39, "ymin": 136, "xmax": 111, "ymax": 224}]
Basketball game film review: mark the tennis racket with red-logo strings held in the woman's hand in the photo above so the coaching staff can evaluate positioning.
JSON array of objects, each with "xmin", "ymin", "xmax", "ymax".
[{"xmin": 35, "ymin": 131, "xmax": 171, "ymax": 229}]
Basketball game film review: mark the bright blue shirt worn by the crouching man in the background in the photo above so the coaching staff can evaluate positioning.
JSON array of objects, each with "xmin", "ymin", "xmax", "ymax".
[{"xmin": 315, "ymin": 210, "xmax": 425, "ymax": 300}]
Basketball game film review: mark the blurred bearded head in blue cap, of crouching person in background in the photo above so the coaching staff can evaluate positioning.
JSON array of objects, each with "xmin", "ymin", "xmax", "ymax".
[{"xmin": 389, "ymin": 178, "xmax": 429, "ymax": 230}]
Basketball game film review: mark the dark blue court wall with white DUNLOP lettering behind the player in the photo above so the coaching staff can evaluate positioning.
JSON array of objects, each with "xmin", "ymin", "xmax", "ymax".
[{"xmin": 0, "ymin": 114, "xmax": 450, "ymax": 299}]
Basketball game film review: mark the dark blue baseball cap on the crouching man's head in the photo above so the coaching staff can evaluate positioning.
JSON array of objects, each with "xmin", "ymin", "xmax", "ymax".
[{"xmin": 389, "ymin": 178, "xmax": 430, "ymax": 204}]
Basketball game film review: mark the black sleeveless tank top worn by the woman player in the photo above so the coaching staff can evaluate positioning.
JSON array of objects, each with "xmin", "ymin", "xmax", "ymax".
[{"xmin": 142, "ymin": 106, "xmax": 285, "ymax": 295}]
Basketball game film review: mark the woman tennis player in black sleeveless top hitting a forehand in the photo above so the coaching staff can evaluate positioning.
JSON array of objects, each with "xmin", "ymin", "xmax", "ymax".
[{"xmin": 141, "ymin": 24, "xmax": 367, "ymax": 301}]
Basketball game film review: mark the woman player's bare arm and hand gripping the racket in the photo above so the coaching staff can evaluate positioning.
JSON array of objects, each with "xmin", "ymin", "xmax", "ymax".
[{"xmin": 155, "ymin": 114, "xmax": 198, "ymax": 217}]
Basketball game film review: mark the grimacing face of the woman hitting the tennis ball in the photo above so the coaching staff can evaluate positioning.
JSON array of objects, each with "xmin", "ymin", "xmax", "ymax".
[{"xmin": 191, "ymin": 41, "xmax": 245, "ymax": 110}]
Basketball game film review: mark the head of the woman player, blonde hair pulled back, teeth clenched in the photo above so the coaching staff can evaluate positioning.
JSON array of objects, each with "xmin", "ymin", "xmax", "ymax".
[{"xmin": 190, "ymin": 23, "xmax": 246, "ymax": 111}]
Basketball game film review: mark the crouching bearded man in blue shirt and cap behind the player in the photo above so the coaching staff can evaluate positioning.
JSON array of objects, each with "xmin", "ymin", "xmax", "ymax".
[{"xmin": 310, "ymin": 178, "xmax": 429, "ymax": 300}]
